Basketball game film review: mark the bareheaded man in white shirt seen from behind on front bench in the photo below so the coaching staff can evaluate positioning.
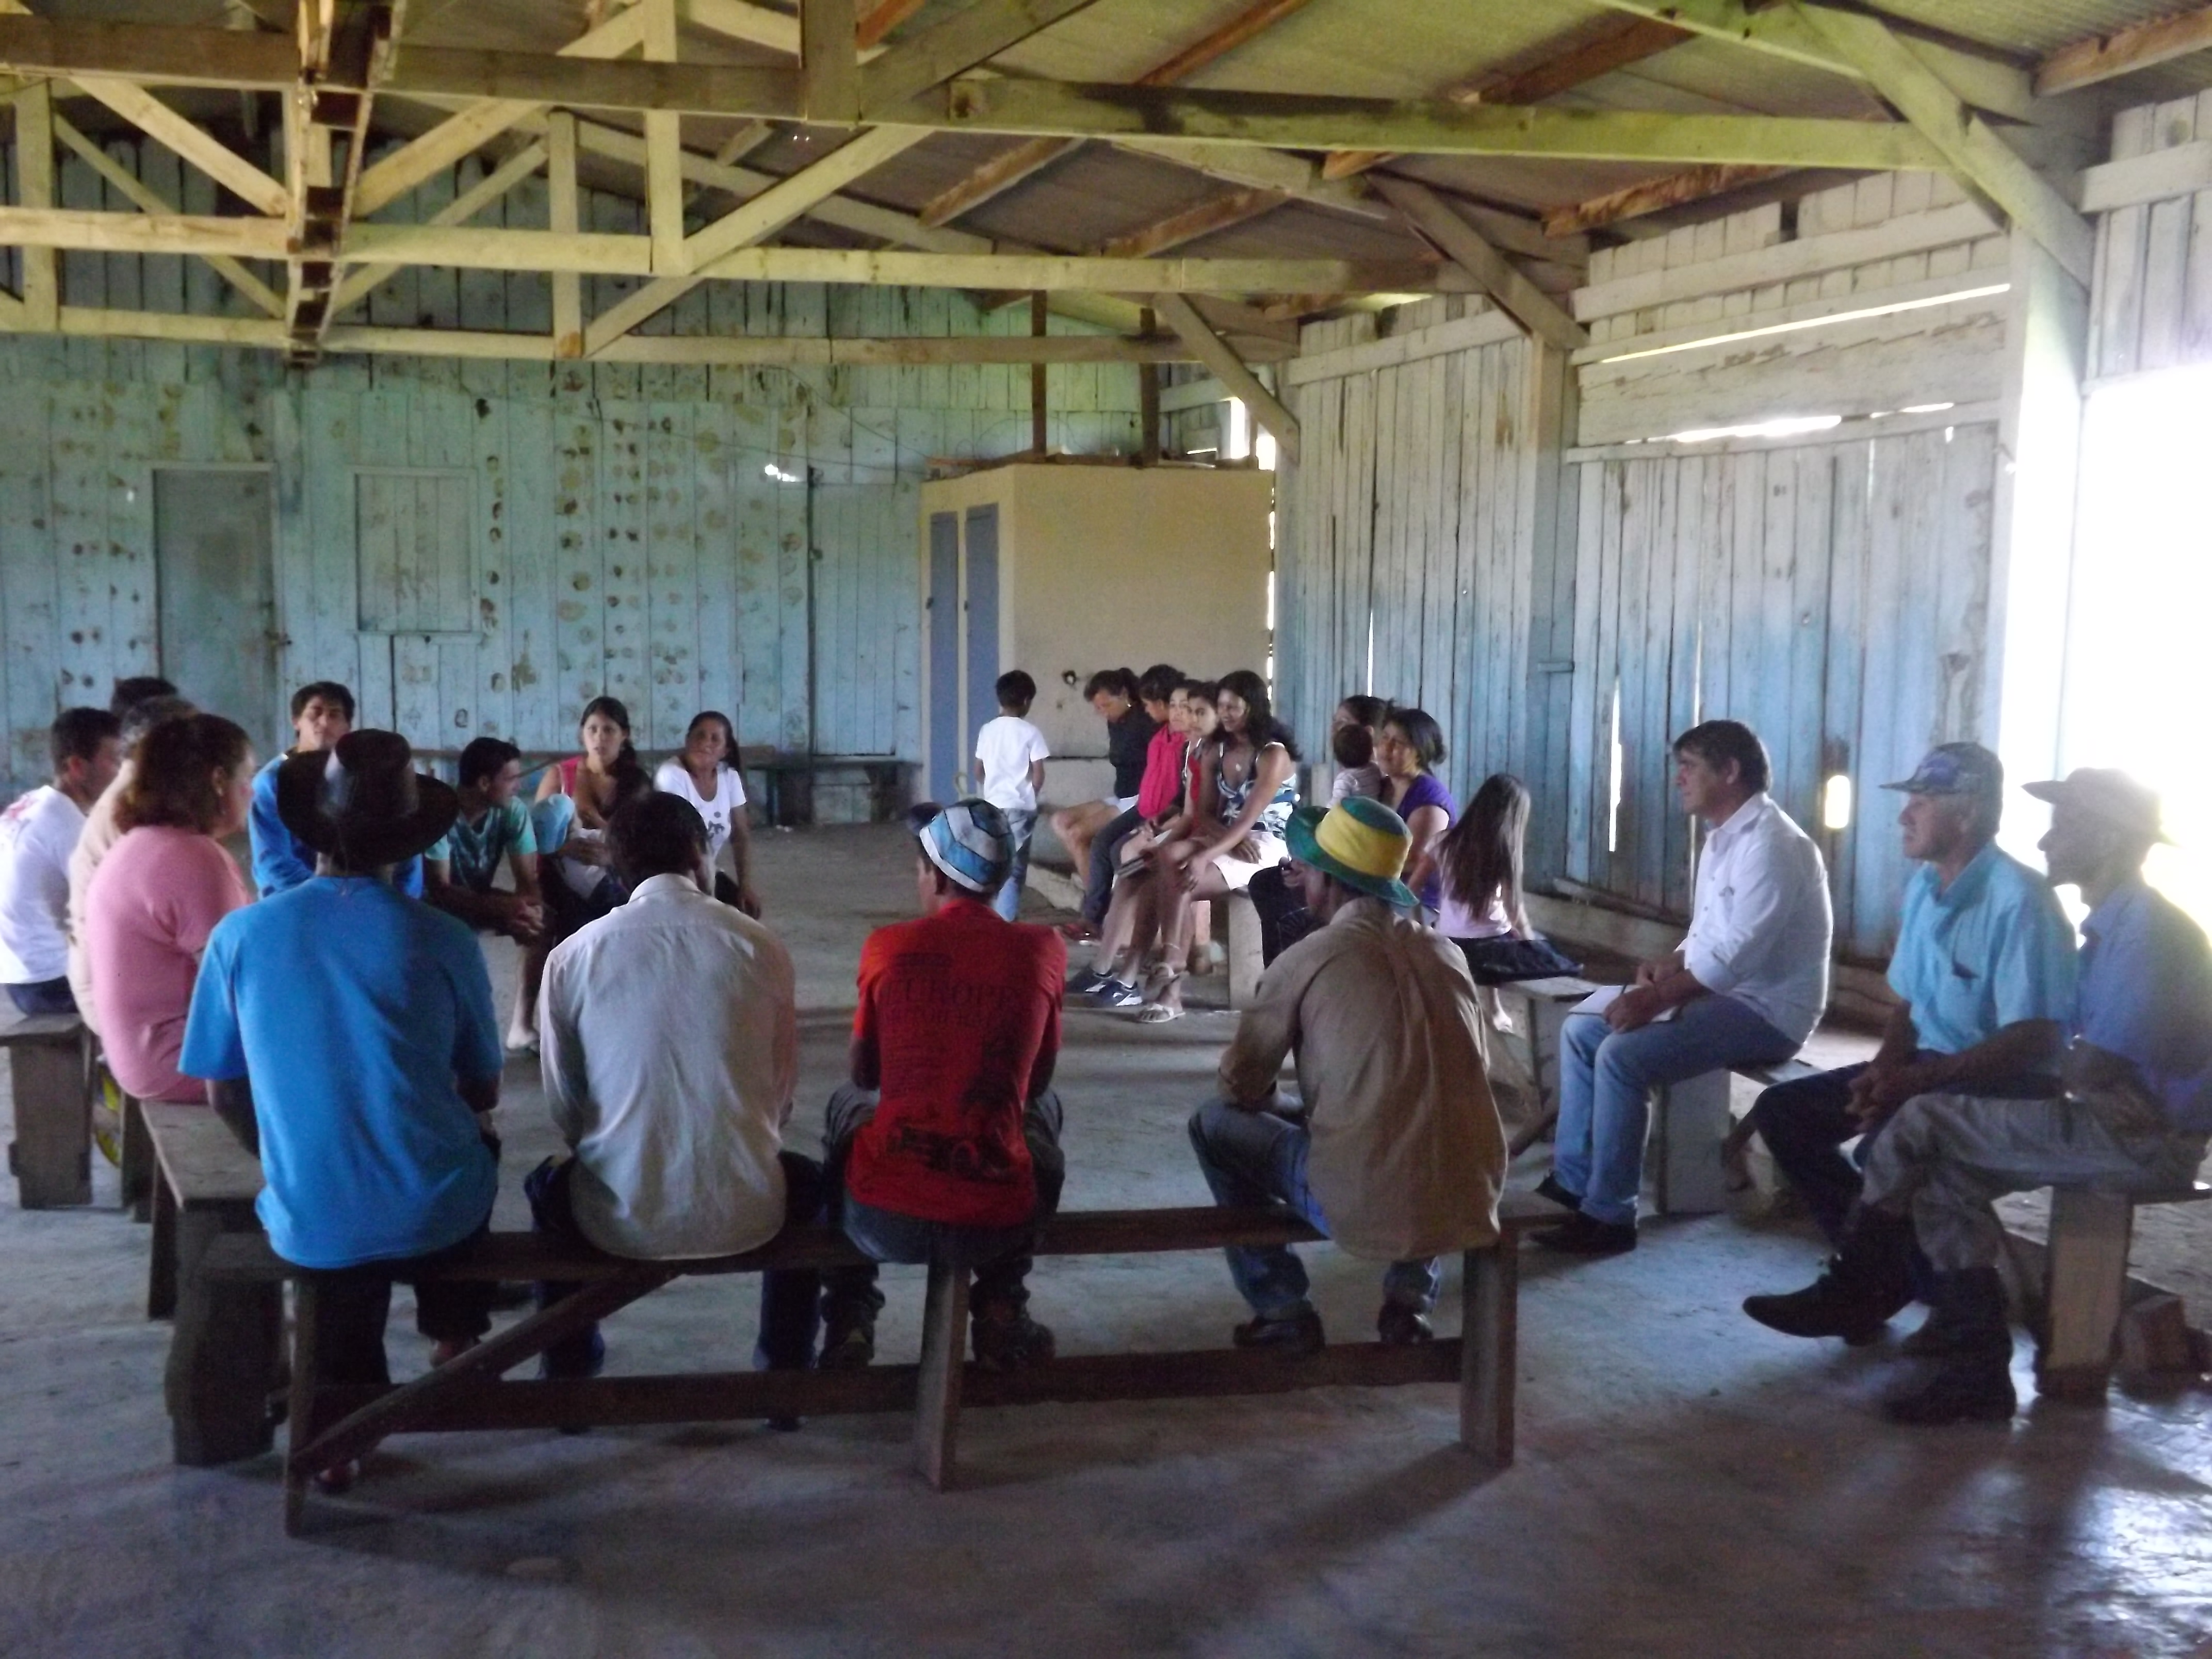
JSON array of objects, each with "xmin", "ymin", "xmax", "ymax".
[{"xmin": 522, "ymin": 794, "xmax": 821, "ymax": 1376}]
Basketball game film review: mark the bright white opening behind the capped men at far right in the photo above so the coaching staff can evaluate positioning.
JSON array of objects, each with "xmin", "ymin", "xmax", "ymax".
[{"xmin": 2061, "ymin": 367, "xmax": 2212, "ymax": 924}]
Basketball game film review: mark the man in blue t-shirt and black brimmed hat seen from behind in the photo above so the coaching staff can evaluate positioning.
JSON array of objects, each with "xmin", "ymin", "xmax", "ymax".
[{"xmin": 179, "ymin": 732, "xmax": 505, "ymax": 1489}]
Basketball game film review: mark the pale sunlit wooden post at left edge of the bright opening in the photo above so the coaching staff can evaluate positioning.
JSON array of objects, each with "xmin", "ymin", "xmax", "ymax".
[{"xmin": 1980, "ymin": 230, "xmax": 2088, "ymax": 856}]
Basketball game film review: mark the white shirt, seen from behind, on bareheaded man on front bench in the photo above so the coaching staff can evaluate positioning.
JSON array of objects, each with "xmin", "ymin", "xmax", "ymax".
[{"xmin": 538, "ymin": 876, "xmax": 799, "ymax": 1261}]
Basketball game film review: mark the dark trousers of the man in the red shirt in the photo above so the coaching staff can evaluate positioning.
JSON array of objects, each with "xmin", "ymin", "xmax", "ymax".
[{"xmin": 823, "ymin": 1084, "xmax": 1068, "ymax": 1325}]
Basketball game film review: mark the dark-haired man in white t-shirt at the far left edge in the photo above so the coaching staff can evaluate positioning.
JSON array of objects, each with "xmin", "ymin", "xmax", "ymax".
[{"xmin": 0, "ymin": 708, "xmax": 122, "ymax": 1013}]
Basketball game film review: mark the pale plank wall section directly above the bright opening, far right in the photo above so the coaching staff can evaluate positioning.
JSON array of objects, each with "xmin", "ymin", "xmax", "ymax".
[{"xmin": 2088, "ymin": 93, "xmax": 2212, "ymax": 378}]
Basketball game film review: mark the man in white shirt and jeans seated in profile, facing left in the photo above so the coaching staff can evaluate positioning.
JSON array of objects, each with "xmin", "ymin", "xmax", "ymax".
[{"xmin": 1535, "ymin": 721, "xmax": 1834, "ymax": 1257}]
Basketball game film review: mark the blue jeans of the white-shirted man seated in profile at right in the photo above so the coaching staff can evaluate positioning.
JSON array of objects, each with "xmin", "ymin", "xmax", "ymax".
[{"xmin": 1551, "ymin": 996, "xmax": 1798, "ymax": 1226}]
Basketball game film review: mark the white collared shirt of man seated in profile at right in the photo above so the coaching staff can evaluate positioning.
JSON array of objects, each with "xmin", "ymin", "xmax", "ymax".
[{"xmin": 1681, "ymin": 794, "xmax": 1836, "ymax": 1042}]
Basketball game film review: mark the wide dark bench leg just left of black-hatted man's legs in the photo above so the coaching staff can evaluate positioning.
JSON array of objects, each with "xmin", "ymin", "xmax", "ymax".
[{"xmin": 164, "ymin": 1210, "xmax": 283, "ymax": 1469}]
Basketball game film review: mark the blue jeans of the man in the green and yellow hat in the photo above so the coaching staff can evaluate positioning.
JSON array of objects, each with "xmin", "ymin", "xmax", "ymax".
[{"xmin": 1190, "ymin": 1091, "xmax": 1444, "ymax": 1319}]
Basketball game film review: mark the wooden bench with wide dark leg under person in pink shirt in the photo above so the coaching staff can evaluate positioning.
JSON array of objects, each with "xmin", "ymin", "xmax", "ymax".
[{"xmin": 141, "ymin": 1101, "xmax": 283, "ymax": 1467}]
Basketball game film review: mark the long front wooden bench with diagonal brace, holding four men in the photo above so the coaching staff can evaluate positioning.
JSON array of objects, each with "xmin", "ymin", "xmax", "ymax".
[{"xmin": 199, "ymin": 1195, "xmax": 1559, "ymax": 1533}]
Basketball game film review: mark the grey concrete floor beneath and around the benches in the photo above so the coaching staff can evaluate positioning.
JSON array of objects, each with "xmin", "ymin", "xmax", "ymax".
[{"xmin": 0, "ymin": 829, "xmax": 2212, "ymax": 1659}]
